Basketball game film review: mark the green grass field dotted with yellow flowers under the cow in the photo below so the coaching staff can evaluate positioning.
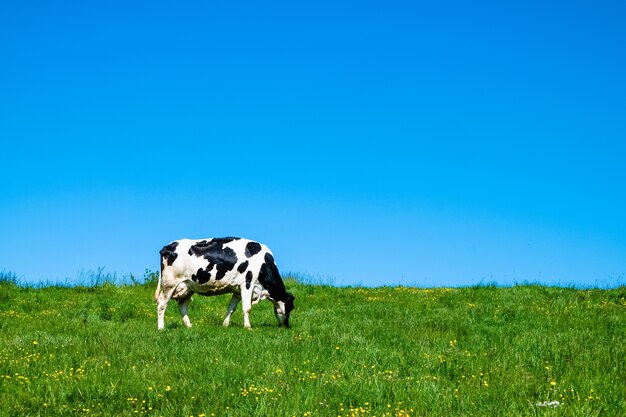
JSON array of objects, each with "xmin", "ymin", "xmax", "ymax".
[{"xmin": 0, "ymin": 272, "xmax": 626, "ymax": 416}]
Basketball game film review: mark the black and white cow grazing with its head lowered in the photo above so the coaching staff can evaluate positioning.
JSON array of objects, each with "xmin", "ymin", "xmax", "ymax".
[{"xmin": 154, "ymin": 237, "xmax": 294, "ymax": 330}]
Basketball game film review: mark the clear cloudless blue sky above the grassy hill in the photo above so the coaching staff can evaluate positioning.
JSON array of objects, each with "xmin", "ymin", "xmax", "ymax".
[{"xmin": 0, "ymin": 0, "xmax": 626, "ymax": 286}]
